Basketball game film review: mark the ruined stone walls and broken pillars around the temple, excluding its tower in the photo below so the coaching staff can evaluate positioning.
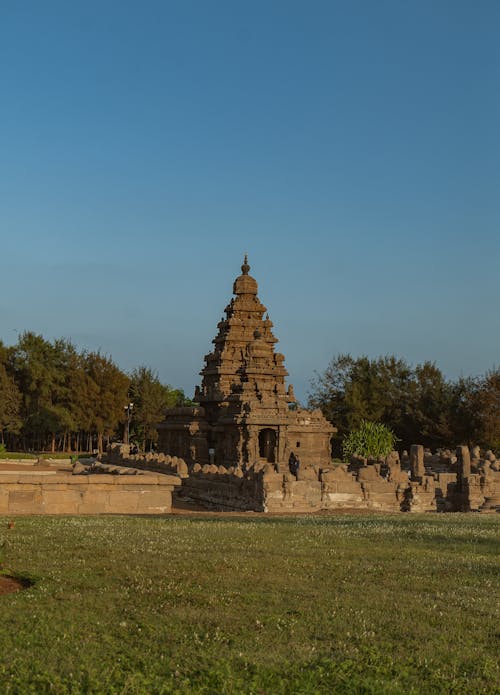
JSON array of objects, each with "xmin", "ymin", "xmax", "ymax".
[{"xmin": 102, "ymin": 445, "xmax": 500, "ymax": 513}]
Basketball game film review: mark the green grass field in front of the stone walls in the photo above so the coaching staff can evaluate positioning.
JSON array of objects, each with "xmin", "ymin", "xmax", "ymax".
[{"xmin": 0, "ymin": 514, "xmax": 500, "ymax": 695}]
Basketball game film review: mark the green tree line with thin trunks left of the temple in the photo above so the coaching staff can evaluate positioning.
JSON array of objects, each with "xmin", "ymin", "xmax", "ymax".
[{"xmin": 0, "ymin": 331, "xmax": 189, "ymax": 452}]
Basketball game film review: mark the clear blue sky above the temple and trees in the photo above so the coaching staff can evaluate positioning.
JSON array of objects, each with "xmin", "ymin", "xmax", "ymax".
[{"xmin": 0, "ymin": 0, "xmax": 500, "ymax": 399}]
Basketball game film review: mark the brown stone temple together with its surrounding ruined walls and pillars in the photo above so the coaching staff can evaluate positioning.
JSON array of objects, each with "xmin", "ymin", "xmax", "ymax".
[{"xmin": 94, "ymin": 256, "xmax": 488, "ymax": 512}]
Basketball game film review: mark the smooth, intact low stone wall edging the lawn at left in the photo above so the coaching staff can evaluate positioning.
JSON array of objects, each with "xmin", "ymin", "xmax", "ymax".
[{"xmin": 0, "ymin": 471, "xmax": 181, "ymax": 515}]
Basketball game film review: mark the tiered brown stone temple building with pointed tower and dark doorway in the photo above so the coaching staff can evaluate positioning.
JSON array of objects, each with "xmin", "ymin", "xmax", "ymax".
[{"xmin": 158, "ymin": 256, "xmax": 335, "ymax": 470}]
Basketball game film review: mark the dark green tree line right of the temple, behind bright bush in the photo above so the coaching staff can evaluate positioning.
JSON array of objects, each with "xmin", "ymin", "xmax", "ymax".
[{"xmin": 309, "ymin": 354, "xmax": 500, "ymax": 453}]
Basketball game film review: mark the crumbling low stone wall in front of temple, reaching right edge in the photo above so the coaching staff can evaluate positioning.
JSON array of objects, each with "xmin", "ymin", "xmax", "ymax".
[{"xmin": 179, "ymin": 465, "xmax": 500, "ymax": 513}]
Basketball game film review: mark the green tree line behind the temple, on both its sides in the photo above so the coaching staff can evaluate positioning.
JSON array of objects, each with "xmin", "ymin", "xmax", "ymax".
[{"xmin": 0, "ymin": 332, "xmax": 500, "ymax": 453}]
